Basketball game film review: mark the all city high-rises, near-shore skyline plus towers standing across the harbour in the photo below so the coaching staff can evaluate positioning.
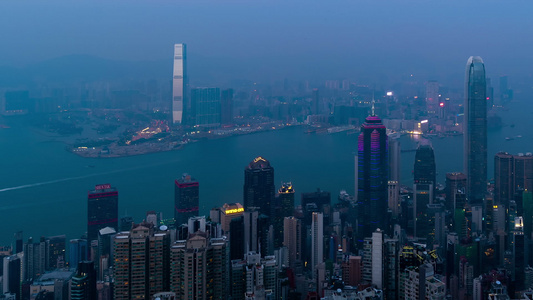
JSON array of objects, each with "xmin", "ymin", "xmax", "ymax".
[{"xmin": 0, "ymin": 56, "xmax": 533, "ymax": 300}]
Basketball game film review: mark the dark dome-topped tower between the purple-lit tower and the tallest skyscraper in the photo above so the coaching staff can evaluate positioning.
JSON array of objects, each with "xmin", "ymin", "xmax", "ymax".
[{"xmin": 414, "ymin": 140, "xmax": 437, "ymax": 186}]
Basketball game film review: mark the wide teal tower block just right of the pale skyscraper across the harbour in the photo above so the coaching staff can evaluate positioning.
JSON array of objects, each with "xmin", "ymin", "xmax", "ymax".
[{"xmin": 191, "ymin": 88, "xmax": 221, "ymax": 129}]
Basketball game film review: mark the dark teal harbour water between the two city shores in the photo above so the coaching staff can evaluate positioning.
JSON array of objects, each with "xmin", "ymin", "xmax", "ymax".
[{"xmin": 0, "ymin": 102, "xmax": 533, "ymax": 245}]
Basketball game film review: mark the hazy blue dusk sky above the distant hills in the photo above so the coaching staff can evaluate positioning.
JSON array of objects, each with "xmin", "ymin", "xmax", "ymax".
[{"xmin": 0, "ymin": 0, "xmax": 533, "ymax": 83}]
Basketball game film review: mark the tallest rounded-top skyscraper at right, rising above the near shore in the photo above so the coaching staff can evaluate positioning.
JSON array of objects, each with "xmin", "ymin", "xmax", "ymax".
[{"xmin": 463, "ymin": 56, "xmax": 487, "ymax": 204}]
